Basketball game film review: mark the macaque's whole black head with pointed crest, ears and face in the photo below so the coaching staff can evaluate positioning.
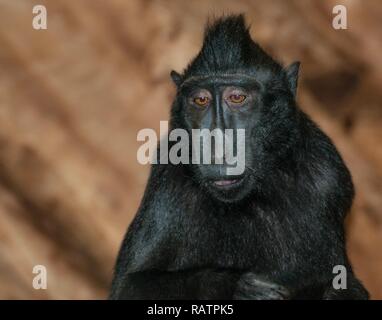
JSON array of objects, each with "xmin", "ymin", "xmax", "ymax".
[{"xmin": 170, "ymin": 15, "xmax": 299, "ymax": 203}]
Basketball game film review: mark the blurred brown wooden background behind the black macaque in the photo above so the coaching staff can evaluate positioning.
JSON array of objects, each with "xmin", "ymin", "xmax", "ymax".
[{"xmin": 0, "ymin": 0, "xmax": 382, "ymax": 299}]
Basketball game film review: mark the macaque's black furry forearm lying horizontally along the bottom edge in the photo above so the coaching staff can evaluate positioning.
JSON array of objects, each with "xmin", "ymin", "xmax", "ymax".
[{"xmin": 111, "ymin": 269, "xmax": 239, "ymax": 300}]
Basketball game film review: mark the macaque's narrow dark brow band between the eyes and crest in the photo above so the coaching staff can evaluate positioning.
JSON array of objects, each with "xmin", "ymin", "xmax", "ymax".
[{"xmin": 181, "ymin": 73, "xmax": 260, "ymax": 90}]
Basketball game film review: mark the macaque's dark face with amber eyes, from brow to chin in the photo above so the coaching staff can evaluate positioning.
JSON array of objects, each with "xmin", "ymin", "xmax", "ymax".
[{"xmin": 171, "ymin": 74, "xmax": 298, "ymax": 202}]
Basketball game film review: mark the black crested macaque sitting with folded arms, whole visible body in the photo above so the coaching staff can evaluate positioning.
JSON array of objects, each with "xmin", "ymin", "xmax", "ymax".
[{"xmin": 110, "ymin": 15, "xmax": 368, "ymax": 299}]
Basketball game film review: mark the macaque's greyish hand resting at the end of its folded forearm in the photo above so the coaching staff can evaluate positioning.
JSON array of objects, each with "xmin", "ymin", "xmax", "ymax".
[{"xmin": 233, "ymin": 272, "xmax": 290, "ymax": 300}]
